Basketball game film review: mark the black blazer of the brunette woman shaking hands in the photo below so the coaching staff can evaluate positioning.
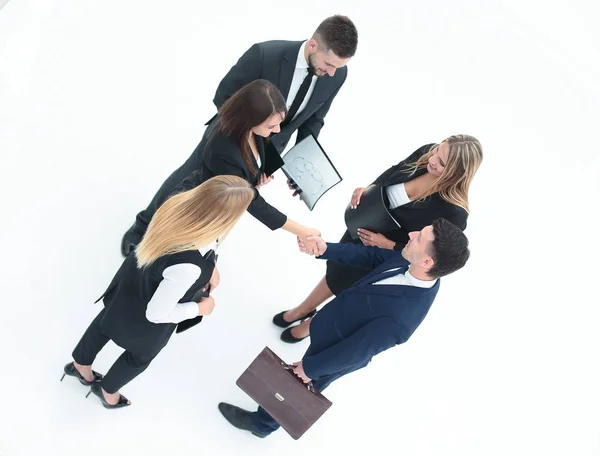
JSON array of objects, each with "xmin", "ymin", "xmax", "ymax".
[{"xmin": 174, "ymin": 122, "xmax": 287, "ymax": 230}]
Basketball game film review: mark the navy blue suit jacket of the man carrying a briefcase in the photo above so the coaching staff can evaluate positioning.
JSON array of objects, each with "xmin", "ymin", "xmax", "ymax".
[{"xmin": 302, "ymin": 243, "xmax": 440, "ymax": 380}]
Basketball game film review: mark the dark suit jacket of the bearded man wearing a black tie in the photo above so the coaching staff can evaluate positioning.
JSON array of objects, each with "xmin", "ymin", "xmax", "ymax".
[{"xmin": 208, "ymin": 40, "xmax": 348, "ymax": 153}]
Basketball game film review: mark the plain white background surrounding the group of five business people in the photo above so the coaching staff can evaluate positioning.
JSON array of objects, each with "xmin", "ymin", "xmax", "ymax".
[{"xmin": 0, "ymin": 0, "xmax": 600, "ymax": 456}]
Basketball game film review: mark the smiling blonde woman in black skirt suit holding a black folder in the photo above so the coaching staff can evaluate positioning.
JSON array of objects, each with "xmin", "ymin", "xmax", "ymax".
[{"xmin": 273, "ymin": 135, "xmax": 483, "ymax": 343}]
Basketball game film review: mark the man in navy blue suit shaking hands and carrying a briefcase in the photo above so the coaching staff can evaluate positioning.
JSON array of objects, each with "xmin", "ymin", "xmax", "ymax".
[{"xmin": 219, "ymin": 219, "xmax": 469, "ymax": 437}]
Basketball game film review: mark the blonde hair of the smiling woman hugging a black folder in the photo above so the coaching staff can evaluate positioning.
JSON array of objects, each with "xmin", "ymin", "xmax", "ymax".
[{"xmin": 407, "ymin": 135, "xmax": 483, "ymax": 213}]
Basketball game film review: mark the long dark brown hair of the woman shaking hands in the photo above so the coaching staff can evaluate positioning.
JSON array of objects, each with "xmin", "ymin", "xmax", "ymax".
[{"xmin": 213, "ymin": 79, "xmax": 287, "ymax": 173}]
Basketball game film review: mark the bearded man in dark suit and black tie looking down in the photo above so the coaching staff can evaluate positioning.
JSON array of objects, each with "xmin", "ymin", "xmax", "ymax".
[{"xmin": 121, "ymin": 16, "xmax": 358, "ymax": 256}]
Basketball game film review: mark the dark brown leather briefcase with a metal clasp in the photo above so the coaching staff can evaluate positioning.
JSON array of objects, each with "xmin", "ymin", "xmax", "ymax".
[{"xmin": 236, "ymin": 347, "xmax": 331, "ymax": 440}]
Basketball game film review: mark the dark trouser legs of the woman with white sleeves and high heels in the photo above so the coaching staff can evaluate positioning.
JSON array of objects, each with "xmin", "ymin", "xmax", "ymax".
[{"xmin": 73, "ymin": 309, "xmax": 156, "ymax": 394}]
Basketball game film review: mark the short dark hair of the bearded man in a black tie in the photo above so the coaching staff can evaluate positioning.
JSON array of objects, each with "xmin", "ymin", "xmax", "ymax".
[{"xmin": 313, "ymin": 15, "xmax": 358, "ymax": 59}]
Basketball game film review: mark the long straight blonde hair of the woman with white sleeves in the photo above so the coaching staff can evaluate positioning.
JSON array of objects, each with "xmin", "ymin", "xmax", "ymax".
[{"xmin": 135, "ymin": 176, "xmax": 255, "ymax": 268}]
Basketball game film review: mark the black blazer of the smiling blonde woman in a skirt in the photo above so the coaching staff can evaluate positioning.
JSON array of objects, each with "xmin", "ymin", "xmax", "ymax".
[{"xmin": 373, "ymin": 144, "xmax": 468, "ymax": 250}]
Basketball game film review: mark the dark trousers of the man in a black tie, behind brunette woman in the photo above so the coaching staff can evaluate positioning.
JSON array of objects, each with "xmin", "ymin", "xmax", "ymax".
[{"xmin": 133, "ymin": 128, "xmax": 210, "ymax": 238}]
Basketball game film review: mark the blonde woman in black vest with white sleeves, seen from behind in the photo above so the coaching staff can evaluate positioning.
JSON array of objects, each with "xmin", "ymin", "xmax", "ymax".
[{"xmin": 61, "ymin": 175, "xmax": 255, "ymax": 409}]
